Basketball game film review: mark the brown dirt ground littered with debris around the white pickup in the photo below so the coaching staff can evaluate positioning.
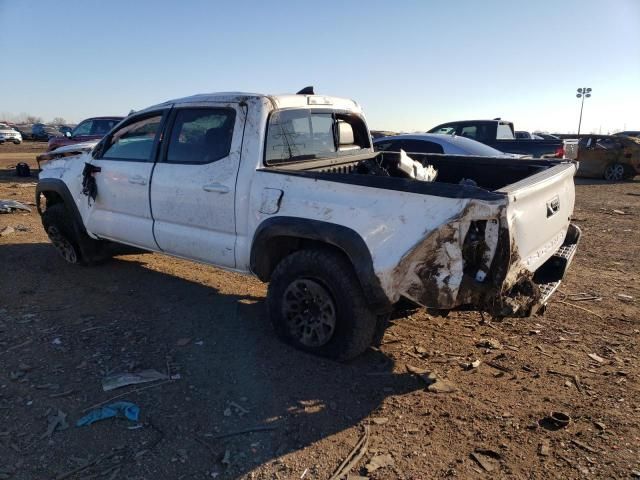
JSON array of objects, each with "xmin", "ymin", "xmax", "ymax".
[{"xmin": 0, "ymin": 143, "xmax": 640, "ymax": 480}]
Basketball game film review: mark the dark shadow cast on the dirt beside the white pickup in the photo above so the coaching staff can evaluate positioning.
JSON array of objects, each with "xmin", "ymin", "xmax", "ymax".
[{"xmin": 0, "ymin": 243, "xmax": 424, "ymax": 478}]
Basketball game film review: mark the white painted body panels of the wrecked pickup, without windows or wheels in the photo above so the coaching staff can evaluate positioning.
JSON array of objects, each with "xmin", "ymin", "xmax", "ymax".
[{"xmin": 40, "ymin": 92, "xmax": 575, "ymax": 316}]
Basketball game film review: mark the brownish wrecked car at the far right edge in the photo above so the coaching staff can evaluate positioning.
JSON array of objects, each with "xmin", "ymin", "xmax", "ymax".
[{"xmin": 576, "ymin": 135, "xmax": 640, "ymax": 182}]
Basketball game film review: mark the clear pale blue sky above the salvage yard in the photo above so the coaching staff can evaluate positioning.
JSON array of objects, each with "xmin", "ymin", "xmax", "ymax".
[{"xmin": 0, "ymin": 0, "xmax": 640, "ymax": 132}]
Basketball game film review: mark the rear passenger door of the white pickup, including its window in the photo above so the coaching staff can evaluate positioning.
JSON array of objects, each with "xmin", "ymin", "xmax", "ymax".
[{"xmin": 151, "ymin": 103, "xmax": 246, "ymax": 268}]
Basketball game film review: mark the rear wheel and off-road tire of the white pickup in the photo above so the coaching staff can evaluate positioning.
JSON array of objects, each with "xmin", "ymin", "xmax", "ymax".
[{"xmin": 267, "ymin": 249, "xmax": 378, "ymax": 361}]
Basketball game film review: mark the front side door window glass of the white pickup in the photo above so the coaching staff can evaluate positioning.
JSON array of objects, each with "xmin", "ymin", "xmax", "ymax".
[{"xmin": 101, "ymin": 114, "xmax": 162, "ymax": 162}]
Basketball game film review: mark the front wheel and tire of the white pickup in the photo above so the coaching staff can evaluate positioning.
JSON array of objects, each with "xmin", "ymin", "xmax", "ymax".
[{"xmin": 42, "ymin": 203, "xmax": 109, "ymax": 265}]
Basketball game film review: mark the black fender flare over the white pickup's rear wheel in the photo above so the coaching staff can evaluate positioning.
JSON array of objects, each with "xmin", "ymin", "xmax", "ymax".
[{"xmin": 250, "ymin": 216, "xmax": 392, "ymax": 314}]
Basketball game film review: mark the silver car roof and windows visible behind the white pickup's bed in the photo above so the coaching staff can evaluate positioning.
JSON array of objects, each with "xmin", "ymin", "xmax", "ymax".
[{"xmin": 373, "ymin": 133, "xmax": 523, "ymax": 158}]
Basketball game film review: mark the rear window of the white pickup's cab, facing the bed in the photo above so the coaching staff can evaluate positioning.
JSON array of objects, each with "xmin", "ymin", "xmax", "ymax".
[{"xmin": 265, "ymin": 109, "xmax": 371, "ymax": 165}]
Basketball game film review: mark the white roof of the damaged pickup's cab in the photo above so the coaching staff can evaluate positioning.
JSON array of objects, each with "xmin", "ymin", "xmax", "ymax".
[{"xmin": 136, "ymin": 92, "xmax": 361, "ymax": 113}]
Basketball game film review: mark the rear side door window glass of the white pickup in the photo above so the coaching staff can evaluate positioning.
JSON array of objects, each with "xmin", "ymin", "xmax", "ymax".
[{"xmin": 166, "ymin": 107, "xmax": 236, "ymax": 165}]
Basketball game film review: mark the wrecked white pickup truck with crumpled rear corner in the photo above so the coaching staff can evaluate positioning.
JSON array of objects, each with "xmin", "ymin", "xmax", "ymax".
[{"xmin": 36, "ymin": 93, "xmax": 580, "ymax": 360}]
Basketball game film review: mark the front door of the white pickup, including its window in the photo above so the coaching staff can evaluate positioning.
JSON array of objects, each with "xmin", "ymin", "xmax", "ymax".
[{"xmin": 86, "ymin": 111, "xmax": 166, "ymax": 250}]
